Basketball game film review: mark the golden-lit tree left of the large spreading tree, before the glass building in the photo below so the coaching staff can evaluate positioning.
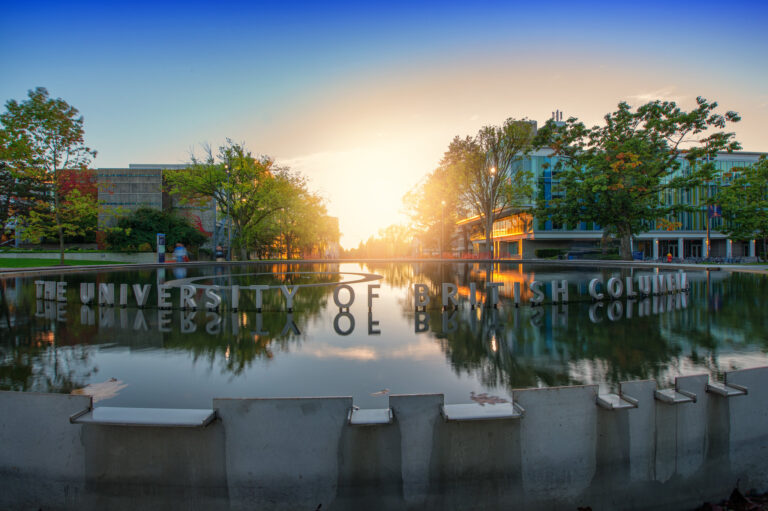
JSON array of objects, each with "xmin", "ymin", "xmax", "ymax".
[{"xmin": 441, "ymin": 118, "xmax": 536, "ymax": 253}]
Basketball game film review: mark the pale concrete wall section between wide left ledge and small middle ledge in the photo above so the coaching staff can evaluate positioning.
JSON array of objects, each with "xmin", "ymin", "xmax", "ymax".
[{"xmin": 213, "ymin": 397, "xmax": 352, "ymax": 510}]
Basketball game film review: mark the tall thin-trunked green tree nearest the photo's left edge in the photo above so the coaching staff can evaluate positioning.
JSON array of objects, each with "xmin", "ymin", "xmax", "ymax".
[{"xmin": 0, "ymin": 87, "xmax": 96, "ymax": 264}]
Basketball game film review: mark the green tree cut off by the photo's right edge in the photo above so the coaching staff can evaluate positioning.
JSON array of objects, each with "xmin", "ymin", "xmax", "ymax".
[{"xmin": 717, "ymin": 156, "xmax": 768, "ymax": 260}]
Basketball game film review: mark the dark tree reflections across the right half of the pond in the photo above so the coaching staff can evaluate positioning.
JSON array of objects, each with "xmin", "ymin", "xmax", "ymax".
[{"xmin": 401, "ymin": 265, "xmax": 768, "ymax": 388}]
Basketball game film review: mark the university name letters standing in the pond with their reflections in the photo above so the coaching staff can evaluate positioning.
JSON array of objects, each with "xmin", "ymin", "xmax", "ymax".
[{"xmin": 35, "ymin": 271, "xmax": 689, "ymax": 336}]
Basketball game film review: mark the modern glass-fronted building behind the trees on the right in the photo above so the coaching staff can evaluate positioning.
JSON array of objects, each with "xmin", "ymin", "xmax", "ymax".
[{"xmin": 457, "ymin": 149, "xmax": 764, "ymax": 259}]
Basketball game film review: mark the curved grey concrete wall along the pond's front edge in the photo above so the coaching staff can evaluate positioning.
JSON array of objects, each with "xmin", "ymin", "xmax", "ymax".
[{"xmin": 0, "ymin": 368, "xmax": 768, "ymax": 511}]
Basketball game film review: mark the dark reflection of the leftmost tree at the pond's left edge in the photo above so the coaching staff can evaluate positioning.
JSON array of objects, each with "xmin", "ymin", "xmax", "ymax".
[{"xmin": 0, "ymin": 279, "xmax": 97, "ymax": 393}]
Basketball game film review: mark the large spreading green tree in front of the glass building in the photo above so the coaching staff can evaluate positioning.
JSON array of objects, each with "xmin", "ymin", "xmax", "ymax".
[{"xmin": 535, "ymin": 98, "xmax": 740, "ymax": 259}]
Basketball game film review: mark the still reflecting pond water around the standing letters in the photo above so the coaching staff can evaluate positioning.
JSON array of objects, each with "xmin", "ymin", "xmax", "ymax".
[{"xmin": 0, "ymin": 263, "xmax": 768, "ymax": 408}]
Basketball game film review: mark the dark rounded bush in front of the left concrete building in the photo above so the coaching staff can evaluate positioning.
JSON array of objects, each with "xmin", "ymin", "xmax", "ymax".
[{"xmin": 106, "ymin": 208, "xmax": 208, "ymax": 250}]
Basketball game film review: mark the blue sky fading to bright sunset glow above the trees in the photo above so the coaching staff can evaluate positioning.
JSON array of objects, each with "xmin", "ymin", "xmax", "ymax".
[{"xmin": 0, "ymin": 0, "xmax": 768, "ymax": 248}]
